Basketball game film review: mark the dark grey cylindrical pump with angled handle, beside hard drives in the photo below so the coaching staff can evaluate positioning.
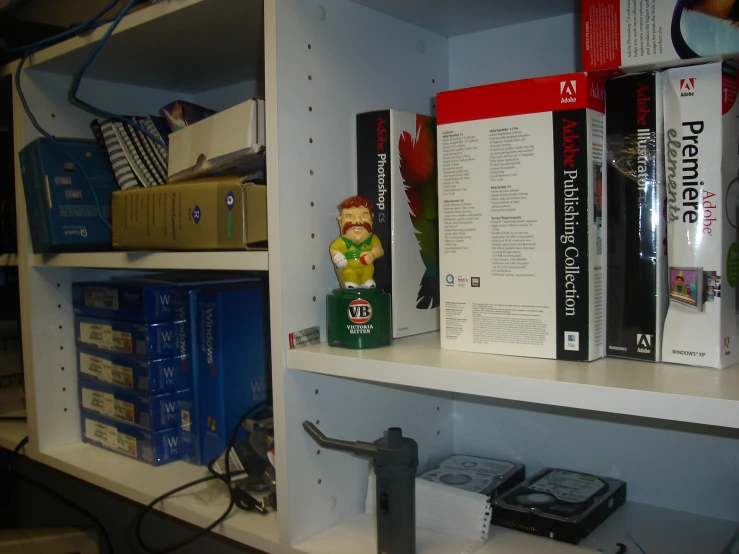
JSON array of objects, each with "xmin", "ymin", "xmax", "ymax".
[{"xmin": 303, "ymin": 421, "xmax": 418, "ymax": 554}]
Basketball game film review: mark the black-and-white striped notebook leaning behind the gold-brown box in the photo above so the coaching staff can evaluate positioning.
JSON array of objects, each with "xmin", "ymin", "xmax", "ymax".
[{"xmin": 91, "ymin": 116, "xmax": 169, "ymax": 190}]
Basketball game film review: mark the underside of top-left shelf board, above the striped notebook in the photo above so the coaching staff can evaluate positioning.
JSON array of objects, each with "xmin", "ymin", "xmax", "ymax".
[{"xmin": 21, "ymin": 0, "xmax": 263, "ymax": 92}]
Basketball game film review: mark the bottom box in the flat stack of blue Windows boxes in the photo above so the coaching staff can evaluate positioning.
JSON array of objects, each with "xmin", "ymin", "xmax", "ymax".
[{"xmin": 81, "ymin": 412, "xmax": 180, "ymax": 466}]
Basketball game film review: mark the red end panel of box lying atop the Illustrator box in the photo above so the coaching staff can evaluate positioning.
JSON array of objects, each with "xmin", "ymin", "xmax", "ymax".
[{"xmin": 581, "ymin": 0, "xmax": 621, "ymax": 71}]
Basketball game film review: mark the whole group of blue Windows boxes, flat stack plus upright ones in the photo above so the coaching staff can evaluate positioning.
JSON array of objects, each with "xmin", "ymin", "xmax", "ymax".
[{"xmin": 73, "ymin": 272, "xmax": 269, "ymax": 465}]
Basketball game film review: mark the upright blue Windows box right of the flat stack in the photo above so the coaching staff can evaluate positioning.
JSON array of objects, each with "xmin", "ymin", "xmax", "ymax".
[{"xmin": 180, "ymin": 283, "xmax": 269, "ymax": 464}]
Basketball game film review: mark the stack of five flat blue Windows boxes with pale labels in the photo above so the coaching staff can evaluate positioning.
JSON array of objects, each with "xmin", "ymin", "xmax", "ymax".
[{"xmin": 72, "ymin": 280, "xmax": 191, "ymax": 465}]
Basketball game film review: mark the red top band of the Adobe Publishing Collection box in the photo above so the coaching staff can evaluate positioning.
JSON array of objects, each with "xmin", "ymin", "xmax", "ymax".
[{"xmin": 436, "ymin": 73, "xmax": 605, "ymax": 125}]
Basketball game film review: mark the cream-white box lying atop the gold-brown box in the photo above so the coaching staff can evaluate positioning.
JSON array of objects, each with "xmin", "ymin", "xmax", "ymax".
[{"xmin": 168, "ymin": 99, "xmax": 266, "ymax": 179}]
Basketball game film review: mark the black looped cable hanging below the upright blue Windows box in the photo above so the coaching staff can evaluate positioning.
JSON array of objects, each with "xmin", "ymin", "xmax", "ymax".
[{"xmin": 131, "ymin": 402, "xmax": 266, "ymax": 554}]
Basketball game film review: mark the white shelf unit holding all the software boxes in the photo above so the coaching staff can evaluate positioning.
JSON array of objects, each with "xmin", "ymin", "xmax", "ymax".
[{"xmin": 5, "ymin": 0, "xmax": 739, "ymax": 554}]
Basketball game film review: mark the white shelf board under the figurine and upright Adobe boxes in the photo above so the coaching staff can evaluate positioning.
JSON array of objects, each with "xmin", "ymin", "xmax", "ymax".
[{"xmin": 287, "ymin": 333, "xmax": 739, "ymax": 428}]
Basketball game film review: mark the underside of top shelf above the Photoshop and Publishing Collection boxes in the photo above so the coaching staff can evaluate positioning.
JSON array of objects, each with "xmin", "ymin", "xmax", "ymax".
[{"xmin": 352, "ymin": 0, "xmax": 578, "ymax": 37}]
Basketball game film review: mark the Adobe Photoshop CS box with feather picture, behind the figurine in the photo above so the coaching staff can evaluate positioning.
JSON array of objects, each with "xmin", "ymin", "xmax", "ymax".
[{"xmin": 357, "ymin": 110, "xmax": 439, "ymax": 338}]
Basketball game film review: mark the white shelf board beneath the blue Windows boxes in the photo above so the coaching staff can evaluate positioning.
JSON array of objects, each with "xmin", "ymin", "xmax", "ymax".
[{"xmin": 32, "ymin": 442, "xmax": 294, "ymax": 554}]
